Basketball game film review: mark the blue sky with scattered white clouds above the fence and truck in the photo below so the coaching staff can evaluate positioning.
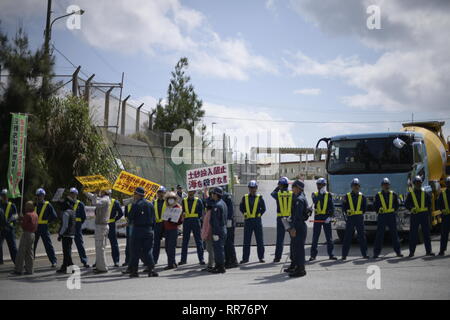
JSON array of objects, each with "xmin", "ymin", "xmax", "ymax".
[{"xmin": 0, "ymin": 0, "xmax": 450, "ymax": 158}]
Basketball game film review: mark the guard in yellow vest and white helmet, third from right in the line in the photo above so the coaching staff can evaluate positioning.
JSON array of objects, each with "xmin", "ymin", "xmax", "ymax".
[{"xmin": 373, "ymin": 178, "xmax": 403, "ymax": 259}]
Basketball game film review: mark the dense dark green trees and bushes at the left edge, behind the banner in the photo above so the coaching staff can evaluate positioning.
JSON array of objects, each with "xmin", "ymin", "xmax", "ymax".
[{"xmin": 0, "ymin": 26, "xmax": 118, "ymax": 200}]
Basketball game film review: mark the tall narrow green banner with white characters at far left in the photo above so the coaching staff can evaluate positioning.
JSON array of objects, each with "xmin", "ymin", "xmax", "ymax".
[{"xmin": 7, "ymin": 113, "xmax": 28, "ymax": 198}]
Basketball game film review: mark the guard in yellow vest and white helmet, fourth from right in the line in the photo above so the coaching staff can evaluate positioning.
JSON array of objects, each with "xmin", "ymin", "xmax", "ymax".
[{"xmin": 342, "ymin": 178, "xmax": 369, "ymax": 260}]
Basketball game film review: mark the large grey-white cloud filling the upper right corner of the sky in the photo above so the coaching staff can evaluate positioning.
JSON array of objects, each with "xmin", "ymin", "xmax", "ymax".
[{"xmin": 284, "ymin": 0, "xmax": 450, "ymax": 113}]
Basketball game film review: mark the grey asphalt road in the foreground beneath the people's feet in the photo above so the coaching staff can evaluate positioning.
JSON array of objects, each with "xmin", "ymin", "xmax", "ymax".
[{"xmin": 0, "ymin": 224, "xmax": 450, "ymax": 300}]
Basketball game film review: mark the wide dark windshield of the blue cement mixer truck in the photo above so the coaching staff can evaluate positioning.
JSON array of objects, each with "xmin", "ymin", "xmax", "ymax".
[{"xmin": 327, "ymin": 137, "xmax": 413, "ymax": 174}]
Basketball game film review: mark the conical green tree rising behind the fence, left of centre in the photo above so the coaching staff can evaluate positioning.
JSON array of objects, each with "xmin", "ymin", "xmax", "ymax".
[{"xmin": 154, "ymin": 58, "xmax": 205, "ymax": 133}]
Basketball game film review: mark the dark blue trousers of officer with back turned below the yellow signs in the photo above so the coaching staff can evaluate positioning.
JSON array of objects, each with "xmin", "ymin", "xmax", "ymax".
[{"xmin": 130, "ymin": 226, "xmax": 155, "ymax": 272}]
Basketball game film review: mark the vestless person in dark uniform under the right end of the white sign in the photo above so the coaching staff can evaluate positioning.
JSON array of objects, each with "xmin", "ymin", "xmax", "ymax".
[{"xmin": 210, "ymin": 187, "xmax": 228, "ymax": 273}]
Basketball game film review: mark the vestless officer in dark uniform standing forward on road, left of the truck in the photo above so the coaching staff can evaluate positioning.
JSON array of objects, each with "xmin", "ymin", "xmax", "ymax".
[{"xmin": 288, "ymin": 180, "xmax": 309, "ymax": 277}]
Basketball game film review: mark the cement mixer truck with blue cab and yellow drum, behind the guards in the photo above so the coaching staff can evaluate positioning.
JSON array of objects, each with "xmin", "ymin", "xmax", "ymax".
[{"xmin": 316, "ymin": 121, "xmax": 450, "ymax": 239}]
